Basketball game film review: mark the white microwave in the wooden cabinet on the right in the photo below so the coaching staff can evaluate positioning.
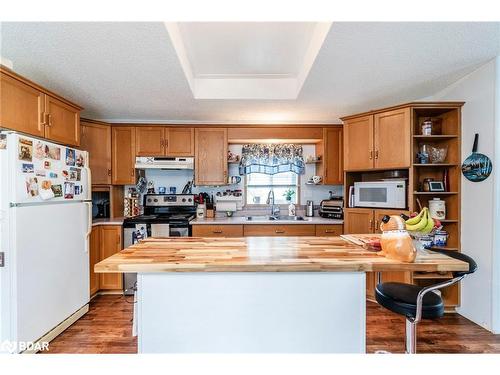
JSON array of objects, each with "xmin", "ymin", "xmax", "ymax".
[{"xmin": 354, "ymin": 180, "xmax": 406, "ymax": 208}]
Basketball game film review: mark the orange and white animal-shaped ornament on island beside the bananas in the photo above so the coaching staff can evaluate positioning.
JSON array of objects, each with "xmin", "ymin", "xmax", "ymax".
[{"xmin": 379, "ymin": 215, "xmax": 417, "ymax": 263}]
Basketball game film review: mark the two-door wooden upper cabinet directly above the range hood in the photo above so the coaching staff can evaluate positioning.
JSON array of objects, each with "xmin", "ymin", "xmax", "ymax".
[{"xmin": 136, "ymin": 126, "xmax": 194, "ymax": 157}]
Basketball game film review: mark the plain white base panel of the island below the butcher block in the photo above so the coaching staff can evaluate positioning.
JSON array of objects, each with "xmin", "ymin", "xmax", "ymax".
[{"xmin": 136, "ymin": 272, "xmax": 366, "ymax": 353}]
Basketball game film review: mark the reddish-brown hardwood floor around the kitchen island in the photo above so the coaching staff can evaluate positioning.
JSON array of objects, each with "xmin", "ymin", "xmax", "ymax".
[{"xmin": 40, "ymin": 295, "xmax": 500, "ymax": 353}]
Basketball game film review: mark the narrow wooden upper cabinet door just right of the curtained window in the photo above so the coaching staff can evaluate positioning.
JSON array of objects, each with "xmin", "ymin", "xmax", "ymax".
[{"xmin": 323, "ymin": 127, "xmax": 344, "ymax": 185}]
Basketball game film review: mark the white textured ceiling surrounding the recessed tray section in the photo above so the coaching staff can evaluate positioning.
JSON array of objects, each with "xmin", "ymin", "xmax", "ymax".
[{"xmin": 0, "ymin": 22, "xmax": 500, "ymax": 124}]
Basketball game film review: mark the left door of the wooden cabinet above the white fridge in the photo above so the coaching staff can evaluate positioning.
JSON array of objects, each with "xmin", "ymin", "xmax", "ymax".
[{"xmin": 0, "ymin": 73, "xmax": 45, "ymax": 137}]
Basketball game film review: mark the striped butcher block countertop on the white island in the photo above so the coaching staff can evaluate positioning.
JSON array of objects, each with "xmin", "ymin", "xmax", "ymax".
[{"xmin": 94, "ymin": 237, "xmax": 468, "ymax": 273}]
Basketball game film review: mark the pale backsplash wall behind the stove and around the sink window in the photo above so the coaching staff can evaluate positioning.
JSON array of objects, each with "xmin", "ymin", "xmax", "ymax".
[{"xmin": 125, "ymin": 144, "xmax": 343, "ymax": 210}]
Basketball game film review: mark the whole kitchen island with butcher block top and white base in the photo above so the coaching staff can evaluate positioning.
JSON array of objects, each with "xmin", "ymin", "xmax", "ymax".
[{"xmin": 95, "ymin": 237, "xmax": 468, "ymax": 353}]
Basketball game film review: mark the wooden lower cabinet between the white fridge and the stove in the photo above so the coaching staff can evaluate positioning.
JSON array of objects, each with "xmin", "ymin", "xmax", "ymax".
[{"xmin": 89, "ymin": 225, "xmax": 122, "ymax": 296}]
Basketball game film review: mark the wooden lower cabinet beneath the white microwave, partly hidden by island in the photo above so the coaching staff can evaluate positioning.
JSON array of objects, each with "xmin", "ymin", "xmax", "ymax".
[{"xmin": 344, "ymin": 208, "xmax": 412, "ymax": 299}]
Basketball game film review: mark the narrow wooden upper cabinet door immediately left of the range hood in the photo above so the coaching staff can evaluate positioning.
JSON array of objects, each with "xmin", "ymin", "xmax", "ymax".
[{"xmin": 111, "ymin": 126, "xmax": 135, "ymax": 185}]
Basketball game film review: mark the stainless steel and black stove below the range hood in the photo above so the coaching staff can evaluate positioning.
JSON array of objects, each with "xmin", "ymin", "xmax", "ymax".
[{"xmin": 123, "ymin": 194, "xmax": 196, "ymax": 295}]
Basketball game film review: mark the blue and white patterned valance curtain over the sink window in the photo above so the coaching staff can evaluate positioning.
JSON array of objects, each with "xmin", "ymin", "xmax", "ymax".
[{"xmin": 240, "ymin": 144, "xmax": 305, "ymax": 175}]
